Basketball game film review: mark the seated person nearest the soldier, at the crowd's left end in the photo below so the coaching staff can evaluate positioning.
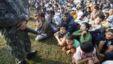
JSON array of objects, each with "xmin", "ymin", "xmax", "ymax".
[{"xmin": 35, "ymin": 12, "xmax": 48, "ymax": 40}]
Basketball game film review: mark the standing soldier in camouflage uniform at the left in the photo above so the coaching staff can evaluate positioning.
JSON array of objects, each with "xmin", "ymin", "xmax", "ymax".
[{"xmin": 0, "ymin": 0, "xmax": 36, "ymax": 64}]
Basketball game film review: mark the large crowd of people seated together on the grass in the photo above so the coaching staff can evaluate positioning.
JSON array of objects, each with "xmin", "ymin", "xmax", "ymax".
[{"xmin": 29, "ymin": 0, "xmax": 113, "ymax": 64}]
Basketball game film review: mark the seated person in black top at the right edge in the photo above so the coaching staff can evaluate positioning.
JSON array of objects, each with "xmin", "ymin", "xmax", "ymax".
[{"xmin": 98, "ymin": 29, "xmax": 113, "ymax": 60}]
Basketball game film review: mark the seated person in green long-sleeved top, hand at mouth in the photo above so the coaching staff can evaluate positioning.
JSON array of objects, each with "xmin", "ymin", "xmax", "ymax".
[{"xmin": 72, "ymin": 23, "xmax": 92, "ymax": 43}]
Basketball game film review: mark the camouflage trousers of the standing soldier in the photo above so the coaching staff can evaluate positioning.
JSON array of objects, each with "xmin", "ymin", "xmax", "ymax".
[{"xmin": 2, "ymin": 28, "xmax": 31, "ymax": 61}]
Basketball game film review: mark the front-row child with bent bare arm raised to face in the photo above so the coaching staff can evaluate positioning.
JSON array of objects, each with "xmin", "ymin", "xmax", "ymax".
[{"xmin": 54, "ymin": 26, "xmax": 67, "ymax": 46}]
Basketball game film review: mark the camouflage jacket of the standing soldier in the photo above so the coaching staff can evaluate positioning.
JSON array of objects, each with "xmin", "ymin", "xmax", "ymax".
[{"xmin": 0, "ymin": 0, "xmax": 29, "ymax": 27}]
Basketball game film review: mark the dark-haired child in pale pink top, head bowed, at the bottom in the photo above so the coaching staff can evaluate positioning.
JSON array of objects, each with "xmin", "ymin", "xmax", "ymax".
[{"xmin": 72, "ymin": 42, "xmax": 99, "ymax": 64}]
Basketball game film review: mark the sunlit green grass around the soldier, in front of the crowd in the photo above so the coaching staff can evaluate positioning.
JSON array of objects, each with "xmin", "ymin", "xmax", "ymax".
[{"xmin": 0, "ymin": 22, "xmax": 71, "ymax": 64}]
